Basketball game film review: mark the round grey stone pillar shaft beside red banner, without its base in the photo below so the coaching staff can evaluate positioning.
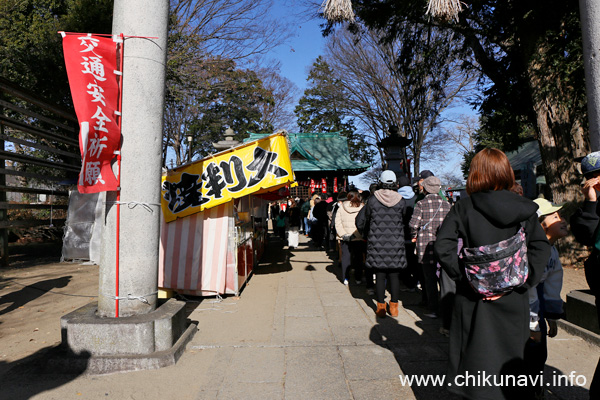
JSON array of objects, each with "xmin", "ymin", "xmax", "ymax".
[{"xmin": 98, "ymin": 0, "xmax": 169, "ymax": 317}]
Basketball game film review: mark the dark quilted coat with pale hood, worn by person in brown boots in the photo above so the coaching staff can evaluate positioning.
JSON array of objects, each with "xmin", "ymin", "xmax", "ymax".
[{"xmin": 356, "ymin": 189, "xmax": 406, "ymax": 269}]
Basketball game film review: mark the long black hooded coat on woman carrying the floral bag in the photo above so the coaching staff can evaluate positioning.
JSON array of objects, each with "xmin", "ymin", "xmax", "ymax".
[{"xmin": 434, "ymin": 190, "xmax": 550, "ymax": 399}]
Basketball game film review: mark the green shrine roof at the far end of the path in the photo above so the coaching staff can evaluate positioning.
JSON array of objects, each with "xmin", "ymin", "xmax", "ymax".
[{"xmin": 244, "ymin": 132, "xmax": 371, "ymax": 174}]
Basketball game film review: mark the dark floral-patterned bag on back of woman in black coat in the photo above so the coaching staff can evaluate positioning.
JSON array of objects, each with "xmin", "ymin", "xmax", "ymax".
[{"xmin": 461, "ymin": 222, "xmax": 529, "ymax": 297}]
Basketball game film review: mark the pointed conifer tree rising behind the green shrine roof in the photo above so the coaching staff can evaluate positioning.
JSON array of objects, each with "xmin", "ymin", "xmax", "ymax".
[{"xmin": 294, "ymin": 56, "xmax": 376, "ymax": 163}]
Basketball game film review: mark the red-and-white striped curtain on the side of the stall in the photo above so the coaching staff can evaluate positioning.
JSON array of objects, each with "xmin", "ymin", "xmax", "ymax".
[{"xmin": 158, "ymin": 201, "xmax": 235, "ymax": 296}]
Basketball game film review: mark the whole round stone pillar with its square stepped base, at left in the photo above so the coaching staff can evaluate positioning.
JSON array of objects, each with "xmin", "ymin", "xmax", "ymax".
[{"xmin": 60, "ymin": 0, "xmax": 196, "ymax": 374}]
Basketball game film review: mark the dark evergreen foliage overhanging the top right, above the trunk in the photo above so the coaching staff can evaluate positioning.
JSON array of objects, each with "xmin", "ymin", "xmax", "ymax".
[{"xmin": 353, "ymin": 0, "xmax": 585, "ymax": 158}]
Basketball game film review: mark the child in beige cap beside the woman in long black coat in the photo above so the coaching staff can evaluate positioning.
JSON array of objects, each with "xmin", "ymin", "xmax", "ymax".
[{"xmin": 525, "ymin": 199, "xmax": 568, "ymax": 398}]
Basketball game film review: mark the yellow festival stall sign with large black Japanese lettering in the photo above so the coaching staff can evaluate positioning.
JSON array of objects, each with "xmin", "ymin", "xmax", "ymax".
[{"xmin": 161, "ymin": 133, "xmax": 294, "ymax": 222}]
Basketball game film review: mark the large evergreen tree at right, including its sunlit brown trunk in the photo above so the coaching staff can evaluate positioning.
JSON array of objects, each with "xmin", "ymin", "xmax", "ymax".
[{"xmin": 346, "ymin": 0, "xmax": 589, "ymax": 202}]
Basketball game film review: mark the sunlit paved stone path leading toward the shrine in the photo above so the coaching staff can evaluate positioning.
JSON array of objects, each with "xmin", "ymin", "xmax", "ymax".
[{"xmin": 0, "ymin": 233, "xmax": 599, "ymax": 400}]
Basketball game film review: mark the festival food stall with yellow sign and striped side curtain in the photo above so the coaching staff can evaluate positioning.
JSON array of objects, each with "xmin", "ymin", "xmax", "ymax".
[{"xmin": 158, "ymin": 133, "xmax": 294, "ymax": 296}]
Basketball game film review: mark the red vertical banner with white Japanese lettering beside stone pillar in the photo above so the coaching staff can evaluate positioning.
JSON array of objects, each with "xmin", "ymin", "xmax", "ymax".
[{"xmin": 61, "ymin": 32, "xmax": 121, "ymax": 193}]
